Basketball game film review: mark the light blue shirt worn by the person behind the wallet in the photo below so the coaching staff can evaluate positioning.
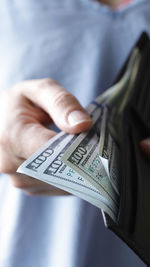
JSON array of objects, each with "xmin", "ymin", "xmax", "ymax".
[{"xmin": 0, "ymin": 0, "xmax": 150, "ymax": 267}]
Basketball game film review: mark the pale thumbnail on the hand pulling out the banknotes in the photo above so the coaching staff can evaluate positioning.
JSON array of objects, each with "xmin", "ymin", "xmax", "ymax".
[{"xmin": 68, "ymin": 110, "xmax": 92, "ymax": 126}]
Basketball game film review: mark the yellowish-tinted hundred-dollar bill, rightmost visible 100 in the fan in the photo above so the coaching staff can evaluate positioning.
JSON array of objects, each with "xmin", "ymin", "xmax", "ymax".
[{"xmin": 62, "ymin": 106, "xmax": 119, "ymax": 211}]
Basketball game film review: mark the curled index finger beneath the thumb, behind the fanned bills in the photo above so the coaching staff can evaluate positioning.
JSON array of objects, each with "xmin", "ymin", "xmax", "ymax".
[{"xmin": 0, "ymin": 122, "xmax": 54, "ymax": 174}]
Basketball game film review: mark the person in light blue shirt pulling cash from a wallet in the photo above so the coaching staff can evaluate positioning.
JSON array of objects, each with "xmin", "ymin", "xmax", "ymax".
[{"xmin": 0, "ymin": 0, "xmax": 150, "ymax": 267}]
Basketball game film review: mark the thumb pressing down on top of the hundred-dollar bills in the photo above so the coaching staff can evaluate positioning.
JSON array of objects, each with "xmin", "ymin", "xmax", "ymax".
[{"xmin": 18, "ymin": 79, "xmax": 92, "ymax": 133}]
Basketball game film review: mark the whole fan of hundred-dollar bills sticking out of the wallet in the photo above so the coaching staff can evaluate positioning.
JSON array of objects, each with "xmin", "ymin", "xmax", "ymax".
[{"xmin": 17, "ymin": 47, "xmax": 141, "ymax": 221}]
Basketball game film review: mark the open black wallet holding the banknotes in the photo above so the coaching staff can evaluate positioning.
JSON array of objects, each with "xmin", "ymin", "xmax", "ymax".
[{"xmin": 104, "ymin": 33, "xmax": 150, "ymax": 266}]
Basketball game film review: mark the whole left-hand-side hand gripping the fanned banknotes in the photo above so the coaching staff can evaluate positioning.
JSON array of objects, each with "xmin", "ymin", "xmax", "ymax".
[{"xmin": 0, "ymin": 79, "xmax": 92, "ymax": 195}]
